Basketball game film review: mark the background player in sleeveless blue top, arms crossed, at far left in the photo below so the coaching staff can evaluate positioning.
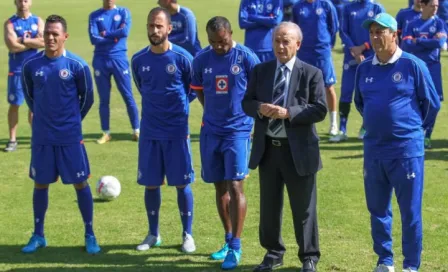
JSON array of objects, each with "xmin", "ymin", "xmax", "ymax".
[{"xmin": 3, "ymin": 0, "xmax": 44, "ymax": 152}]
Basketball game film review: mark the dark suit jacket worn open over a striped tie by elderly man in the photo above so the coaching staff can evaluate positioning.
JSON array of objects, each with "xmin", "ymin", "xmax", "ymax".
[{"xmin": 242, "ymin": 58, "xmax": 327, "ymax": 176}]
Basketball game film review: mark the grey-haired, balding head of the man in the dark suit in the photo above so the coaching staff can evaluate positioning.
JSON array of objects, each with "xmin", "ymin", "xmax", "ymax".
[{"xmin": 272, "ymin": 22, "xmax": 303, "ymax": 63}]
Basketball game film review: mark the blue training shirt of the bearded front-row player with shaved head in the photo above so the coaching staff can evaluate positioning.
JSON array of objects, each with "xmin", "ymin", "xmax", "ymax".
[{"xmin": 131, "ymin": 44, "xmax": 193, "ymax": 140}]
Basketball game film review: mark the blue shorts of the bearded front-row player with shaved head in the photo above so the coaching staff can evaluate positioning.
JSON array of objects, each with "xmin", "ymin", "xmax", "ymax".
[{"xmin": 137, "ymin": 138, "xmax": 194, "ymax": 186}]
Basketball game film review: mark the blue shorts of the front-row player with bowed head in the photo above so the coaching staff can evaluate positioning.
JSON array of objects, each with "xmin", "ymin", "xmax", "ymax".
[{"xmin": 200, "ymin": 133, "xmax": 250, "ymax": 183}]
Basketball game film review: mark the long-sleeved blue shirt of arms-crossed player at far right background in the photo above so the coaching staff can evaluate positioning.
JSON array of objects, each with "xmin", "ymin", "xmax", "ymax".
[{"xmin": 402, "ymin": 16, "xmax": 446, "ymax": 64}]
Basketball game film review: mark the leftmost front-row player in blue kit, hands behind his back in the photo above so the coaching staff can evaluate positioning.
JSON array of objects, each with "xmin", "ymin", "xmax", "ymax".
[{"xmin": 22, "ymin": 15, "xmax": 100, "ymax": 254}]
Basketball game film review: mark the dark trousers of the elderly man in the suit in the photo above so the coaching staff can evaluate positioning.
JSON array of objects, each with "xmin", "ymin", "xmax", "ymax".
[{"xmin": 259, "ymin": 137, "xmax": 320, "ymax": 263}]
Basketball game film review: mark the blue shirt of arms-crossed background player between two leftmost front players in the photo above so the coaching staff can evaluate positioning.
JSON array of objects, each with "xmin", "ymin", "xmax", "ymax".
[{"xmin": 89, "ymin": 6, "xmax": 132, "ymax": 57}]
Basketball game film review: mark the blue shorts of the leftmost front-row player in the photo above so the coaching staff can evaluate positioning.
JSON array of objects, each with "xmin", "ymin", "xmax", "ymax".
[{"xmin": 30, "ymin": 142, "xmax": 90, "ymax": 184}]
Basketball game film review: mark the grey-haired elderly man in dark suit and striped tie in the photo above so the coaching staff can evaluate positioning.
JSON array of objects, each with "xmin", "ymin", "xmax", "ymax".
[{"xmin": 242, "ymin": 22, "xmax": 327, "ymax": 272}]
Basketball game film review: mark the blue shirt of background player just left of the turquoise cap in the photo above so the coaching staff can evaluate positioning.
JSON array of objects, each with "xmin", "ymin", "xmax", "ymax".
[{"xmin": 339, "ymin": 0, "xmax": 384, "ymax": 58}]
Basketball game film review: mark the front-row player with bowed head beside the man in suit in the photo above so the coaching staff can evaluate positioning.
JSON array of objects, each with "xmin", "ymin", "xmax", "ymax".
[{"xmin": 191, "ymin": 16, "xmax": 260, "ymax": 270}]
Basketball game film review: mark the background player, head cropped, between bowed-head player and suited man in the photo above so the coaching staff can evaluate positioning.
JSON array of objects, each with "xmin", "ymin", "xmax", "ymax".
[{"xmin": 239, "ymin": 0, "xmax": 283, "ymax": 62}]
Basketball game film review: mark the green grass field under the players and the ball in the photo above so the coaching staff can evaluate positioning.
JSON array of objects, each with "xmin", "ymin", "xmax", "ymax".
[{"xmin": 0, "ymin": 0, "xmax": 448, "ymax": 272}]
